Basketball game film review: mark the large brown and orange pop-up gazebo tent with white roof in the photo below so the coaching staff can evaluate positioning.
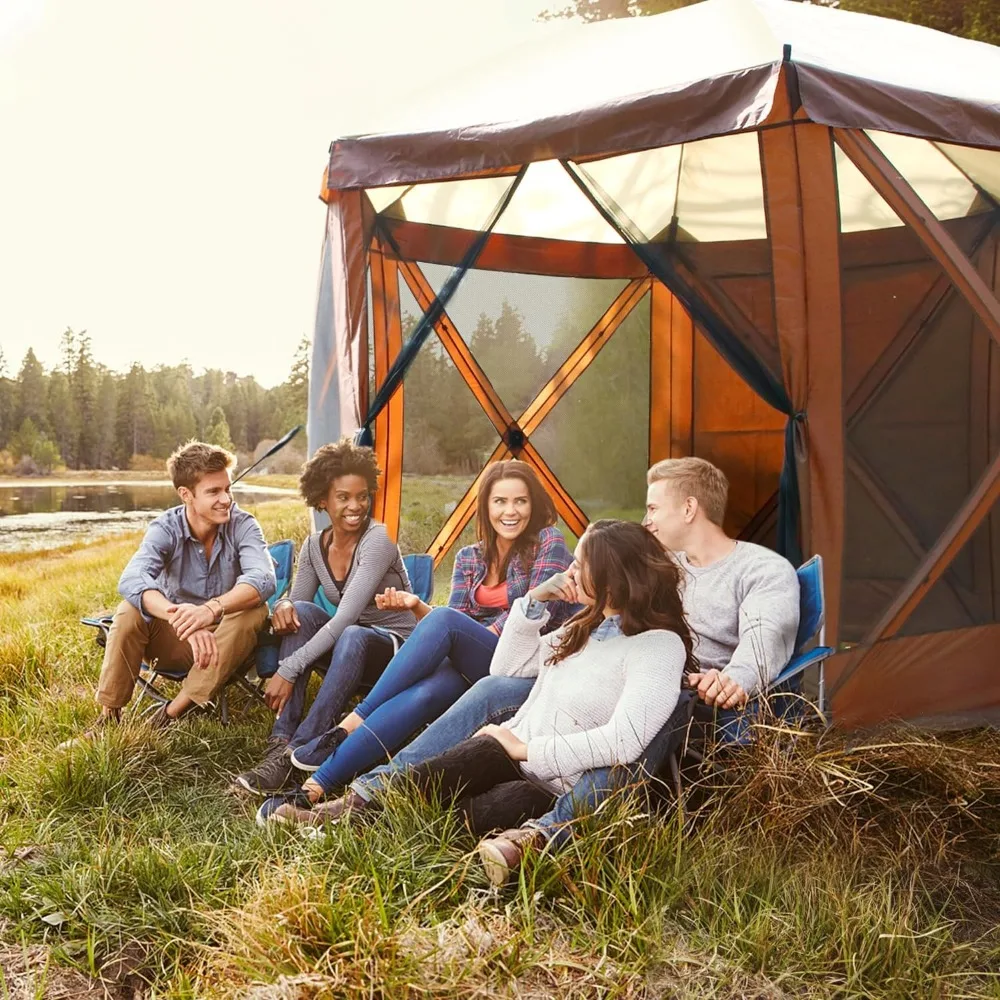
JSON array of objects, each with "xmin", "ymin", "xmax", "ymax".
[{"xmin": 309, "ymin": 0, "xmax": 1000, "ymax": 725}]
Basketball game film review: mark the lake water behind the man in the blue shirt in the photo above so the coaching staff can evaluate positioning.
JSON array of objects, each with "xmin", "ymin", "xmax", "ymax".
[{"xmin": 0, "ymin": 480, "xmax": 297, "ymax": 552}]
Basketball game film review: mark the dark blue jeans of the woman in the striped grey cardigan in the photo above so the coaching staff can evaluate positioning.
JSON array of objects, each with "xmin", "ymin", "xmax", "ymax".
[{"xmin": 271, "ymin": 601, "xmax": 393, "ymax": 749}]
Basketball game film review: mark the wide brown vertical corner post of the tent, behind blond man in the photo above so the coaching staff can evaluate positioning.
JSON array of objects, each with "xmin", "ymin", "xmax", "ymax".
[{"xmin": 760, "ymin": 122, "xmax": 845, "ymax": 642}]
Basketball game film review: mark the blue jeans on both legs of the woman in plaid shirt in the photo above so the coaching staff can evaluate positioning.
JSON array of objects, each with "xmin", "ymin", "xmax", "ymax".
[{"xmin": 311, "ymin": 608, "xmax": 498, "ymax": 791}]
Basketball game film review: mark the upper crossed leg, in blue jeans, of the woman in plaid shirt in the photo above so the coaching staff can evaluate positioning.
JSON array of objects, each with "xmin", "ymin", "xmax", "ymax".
[{"xmin": 345, "ymin": 608, "xmax": 497, "ymax": 732}]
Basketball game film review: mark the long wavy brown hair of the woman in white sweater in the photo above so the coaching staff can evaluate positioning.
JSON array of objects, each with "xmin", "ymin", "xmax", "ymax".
[{"xmin": 549, "ymin": 519, "xmax": 697, "ymax": 671}]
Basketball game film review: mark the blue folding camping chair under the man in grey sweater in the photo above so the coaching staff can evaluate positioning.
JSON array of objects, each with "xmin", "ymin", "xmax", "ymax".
[{"xmin": 712, "ymin": 555, "xmax": 833, "ymax": 744}]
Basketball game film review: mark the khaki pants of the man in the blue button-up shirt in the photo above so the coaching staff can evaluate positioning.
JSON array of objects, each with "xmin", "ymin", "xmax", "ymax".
[{"xmin": 97, "ymin": 601, "xmax": 267, "ymax": 708}]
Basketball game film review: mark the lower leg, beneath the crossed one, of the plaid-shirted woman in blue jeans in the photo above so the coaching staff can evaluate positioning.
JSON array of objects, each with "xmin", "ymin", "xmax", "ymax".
[{"xmin": 309, "ymin": 660, "xmax": 466, "ymax": 793}]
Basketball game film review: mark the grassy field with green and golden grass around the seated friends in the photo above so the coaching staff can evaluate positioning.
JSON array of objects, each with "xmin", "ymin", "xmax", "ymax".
[{"xmin": 0, "ymin": 501, "xmax": 1000, "ymax": 1000}]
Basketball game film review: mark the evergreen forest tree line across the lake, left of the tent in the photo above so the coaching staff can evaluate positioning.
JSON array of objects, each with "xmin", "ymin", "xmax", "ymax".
[{"xmin": 0, "ymin": 330, "xmax": 309, "ymax": 475}]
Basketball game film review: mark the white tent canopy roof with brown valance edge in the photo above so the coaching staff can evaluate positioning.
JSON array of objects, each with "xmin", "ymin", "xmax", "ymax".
[{"xmin": 327, "ymin": 0, "xmax": 1000, "ymax": 189}]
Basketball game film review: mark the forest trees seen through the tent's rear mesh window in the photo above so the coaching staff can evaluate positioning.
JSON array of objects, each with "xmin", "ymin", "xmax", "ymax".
[{"xmin": 403, "ymin": 286, "xmax": 649, "ymax": 509}]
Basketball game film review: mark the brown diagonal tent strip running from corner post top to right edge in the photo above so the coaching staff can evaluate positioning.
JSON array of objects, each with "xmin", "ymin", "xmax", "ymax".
[{"xmin": 833, "ymin": 128, "xmax": 1000, "ymax": 343}]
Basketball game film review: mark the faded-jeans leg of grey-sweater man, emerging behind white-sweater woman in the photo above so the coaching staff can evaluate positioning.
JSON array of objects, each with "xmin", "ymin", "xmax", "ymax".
[{"xmin": 351, "ymin": 672, "xmax": 535, "ymax": 801}]
